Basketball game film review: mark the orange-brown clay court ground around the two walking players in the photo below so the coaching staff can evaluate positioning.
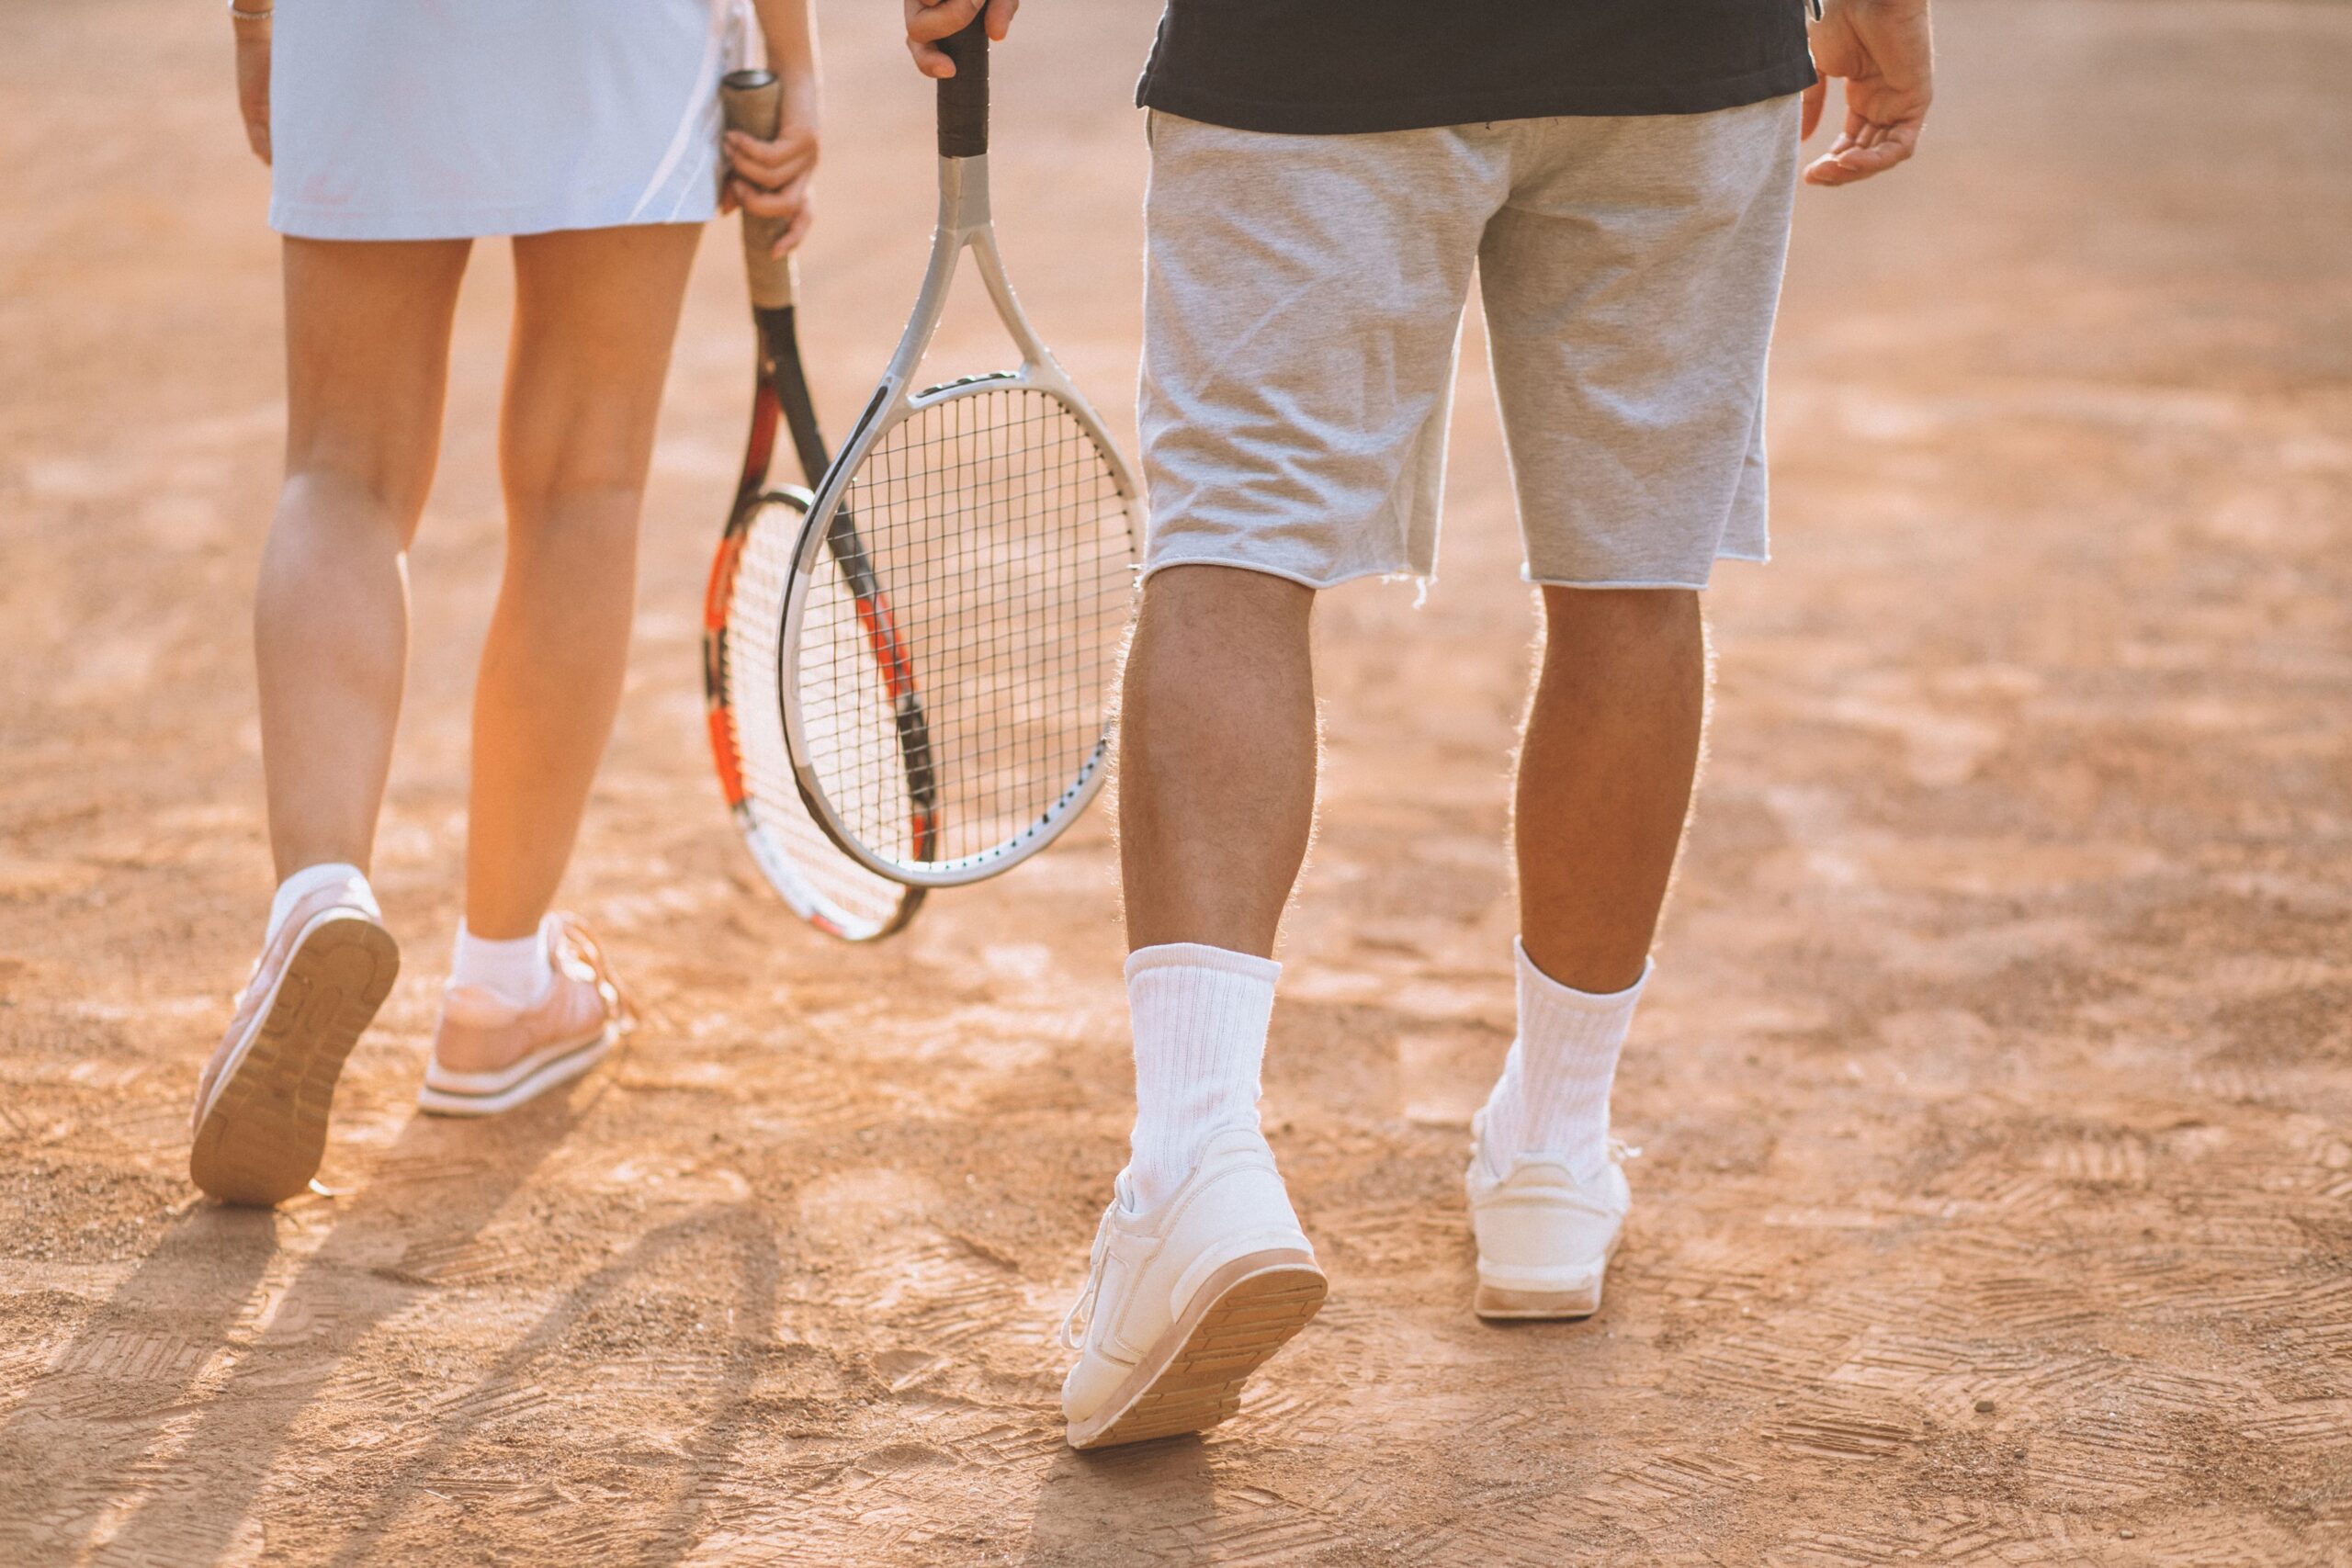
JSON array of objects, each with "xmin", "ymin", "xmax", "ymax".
[{"xmin": 0, "ymin": 0, "xmax": 2352, "ymax": 1568}]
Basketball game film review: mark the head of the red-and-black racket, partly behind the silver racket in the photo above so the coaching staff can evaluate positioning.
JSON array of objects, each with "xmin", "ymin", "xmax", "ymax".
[{"xmin": 703, "ymin": 489, "xmax": 922, "ymax": 942}]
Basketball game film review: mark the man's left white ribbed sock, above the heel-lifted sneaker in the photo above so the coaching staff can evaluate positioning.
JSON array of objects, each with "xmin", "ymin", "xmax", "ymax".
[{"xmin": 1126, "ymin": 942, "xmax": 1282, "ymax": 1208}]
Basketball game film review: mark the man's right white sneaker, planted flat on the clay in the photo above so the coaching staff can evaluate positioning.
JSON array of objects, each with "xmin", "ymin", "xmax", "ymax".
[{"xmin": 1463, "ymin": 1114, "xmax": 1633, "ymax": 1316}]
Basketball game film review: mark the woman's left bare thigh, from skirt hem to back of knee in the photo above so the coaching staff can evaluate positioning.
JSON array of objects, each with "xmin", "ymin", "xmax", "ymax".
[{"xmin": 285, "ymin": 237, "xmax": 470, "ymax": 526}]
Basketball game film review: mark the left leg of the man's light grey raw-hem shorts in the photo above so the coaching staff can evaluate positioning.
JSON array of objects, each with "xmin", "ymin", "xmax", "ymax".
[{"xmin": 1138, "ymin": 113, "xmax": 1510, "ymax": 588}]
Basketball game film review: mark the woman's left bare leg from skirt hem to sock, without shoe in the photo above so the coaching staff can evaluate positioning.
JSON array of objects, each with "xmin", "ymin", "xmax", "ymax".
[{"xmin": 254, "ymin": 240, "xmax": 468, "ymax": 879}]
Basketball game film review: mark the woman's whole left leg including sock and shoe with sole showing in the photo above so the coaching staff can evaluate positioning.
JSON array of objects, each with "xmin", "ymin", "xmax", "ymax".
[{"xmin": 188, "ymin": 240, "xmax": 466, "ymax": 1203}]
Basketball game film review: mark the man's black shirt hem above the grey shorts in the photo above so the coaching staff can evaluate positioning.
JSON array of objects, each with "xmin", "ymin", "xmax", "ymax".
[{"xmin": 1136, "ymin": 0, "xmax": 1814, "ymax": 134}]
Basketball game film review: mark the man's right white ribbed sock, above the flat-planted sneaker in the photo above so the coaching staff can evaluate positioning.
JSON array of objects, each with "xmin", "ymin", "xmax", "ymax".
[{"xmin": 1484, "ymin": 942, "xmax": 1649, "ymax": 1180}]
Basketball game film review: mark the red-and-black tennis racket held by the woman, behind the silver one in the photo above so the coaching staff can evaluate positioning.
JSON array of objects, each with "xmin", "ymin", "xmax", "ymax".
[{"xmin": 703, "ymin": 71, "xmax": 932, "ymax": 942}]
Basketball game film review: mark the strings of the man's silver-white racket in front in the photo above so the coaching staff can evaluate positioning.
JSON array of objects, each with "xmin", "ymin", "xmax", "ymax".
[{"xmin": 797, "ymin": 386, "xmax": 1134, "ymax": 863}]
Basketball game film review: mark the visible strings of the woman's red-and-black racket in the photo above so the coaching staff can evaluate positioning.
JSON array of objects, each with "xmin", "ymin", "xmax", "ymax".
[{"xmin": 722, "ymin": 503, "xmax": 908, "ymax": 936}]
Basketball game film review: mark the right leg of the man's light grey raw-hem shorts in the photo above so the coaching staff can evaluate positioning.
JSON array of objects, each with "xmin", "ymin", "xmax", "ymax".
[{"xmin": 1479, "ymin": 96, "xmax": 1797, "ymax": 588}]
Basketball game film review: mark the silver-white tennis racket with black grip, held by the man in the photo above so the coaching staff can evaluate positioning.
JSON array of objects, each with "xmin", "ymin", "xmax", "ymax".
[{"xmin": 776, "ymin": 21, "xmax": 1136, "ymax": 886}]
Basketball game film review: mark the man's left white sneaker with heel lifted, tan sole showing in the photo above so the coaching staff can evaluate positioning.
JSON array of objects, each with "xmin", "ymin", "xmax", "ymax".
[{"xmin": 1061, "ymin": 1126, "xmax": 1327, "ymax": 1448}]
